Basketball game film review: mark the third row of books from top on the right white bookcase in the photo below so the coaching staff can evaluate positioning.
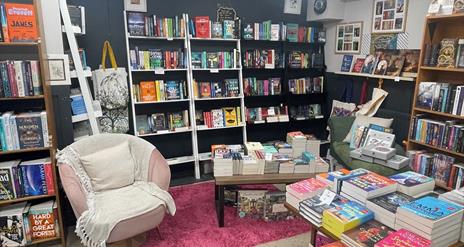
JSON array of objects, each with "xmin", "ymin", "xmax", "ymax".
[{"xmin": 193, "ymin": 79, "xmax": 240, "ymax": 99}]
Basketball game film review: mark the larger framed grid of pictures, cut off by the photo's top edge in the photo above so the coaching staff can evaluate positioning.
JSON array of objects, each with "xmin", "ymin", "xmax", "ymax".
[{"xmin": 372, "ymin": 0, "xmax": 408, "ymax": 33}]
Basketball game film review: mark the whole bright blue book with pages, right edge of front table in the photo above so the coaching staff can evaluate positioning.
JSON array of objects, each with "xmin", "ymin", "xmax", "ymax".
[{"xmin": 398, "ymin": 196, "xmax": 464, "ymax": 228}]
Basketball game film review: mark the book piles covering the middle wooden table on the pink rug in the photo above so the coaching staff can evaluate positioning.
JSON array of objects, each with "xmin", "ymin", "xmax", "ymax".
[{"xmin": 211, "ymin": 131, "xmax": 329, "ymax": 177}]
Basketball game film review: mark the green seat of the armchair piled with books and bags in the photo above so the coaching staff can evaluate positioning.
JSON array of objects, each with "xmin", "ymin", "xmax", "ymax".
[{"xmin": 330, "ymin": 139, "xmax": 409, "ymax": 177}]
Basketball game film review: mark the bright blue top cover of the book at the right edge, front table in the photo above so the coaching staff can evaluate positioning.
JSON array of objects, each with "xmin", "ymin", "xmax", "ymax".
[{"xmin": 399, "ymin": 196, "xmax": 464, "ymax": 221}]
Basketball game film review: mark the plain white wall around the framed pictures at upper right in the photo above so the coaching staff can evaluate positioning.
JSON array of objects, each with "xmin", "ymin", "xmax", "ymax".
[{"xmin": 324, "ymin": 0, "xmax": 430, "ymax": 72}]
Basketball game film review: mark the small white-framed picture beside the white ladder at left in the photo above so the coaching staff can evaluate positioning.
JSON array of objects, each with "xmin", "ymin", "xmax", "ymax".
[{"xmin": 45, "ymin": 54, "xmax": 71, "ymax": 86}]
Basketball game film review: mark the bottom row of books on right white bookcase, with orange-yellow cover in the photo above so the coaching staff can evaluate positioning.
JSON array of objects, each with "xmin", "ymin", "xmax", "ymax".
[{"xmin": 195, "ymin": 107, "xmax": 242, "ymax": 129}]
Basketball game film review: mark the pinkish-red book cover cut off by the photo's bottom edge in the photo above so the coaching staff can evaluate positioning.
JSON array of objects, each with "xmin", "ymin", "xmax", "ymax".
[{"xmin": 374, "ymin": 229, "xmax": 432, "ymax": 247}]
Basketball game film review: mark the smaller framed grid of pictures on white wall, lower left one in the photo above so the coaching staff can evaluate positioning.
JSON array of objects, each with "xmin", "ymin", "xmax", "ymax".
[{"xmin": 335, "ymin": 22, "xmax": 363, "ymax": 53}]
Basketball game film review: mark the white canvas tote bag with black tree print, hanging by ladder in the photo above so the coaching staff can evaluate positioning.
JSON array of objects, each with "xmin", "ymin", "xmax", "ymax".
[{"xmin": 92, "ymin": 41, "xmax": 129, "ymax": 133}]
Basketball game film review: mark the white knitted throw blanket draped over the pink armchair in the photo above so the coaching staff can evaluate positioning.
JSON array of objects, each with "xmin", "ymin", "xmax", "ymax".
[{"xmin": 57, "ymin": 147, "xmax": 176, "ymax": 247}]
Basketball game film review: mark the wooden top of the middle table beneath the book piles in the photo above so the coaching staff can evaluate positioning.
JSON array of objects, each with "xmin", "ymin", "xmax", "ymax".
[{"xmin": 214, "ymin": 173, "xmax": 316, "ymax": 185}]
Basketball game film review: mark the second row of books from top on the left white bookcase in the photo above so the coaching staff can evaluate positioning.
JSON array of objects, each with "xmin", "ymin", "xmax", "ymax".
[{"xmin": 129, "ymin": 46, "xmax": 187, "ymax": 70}]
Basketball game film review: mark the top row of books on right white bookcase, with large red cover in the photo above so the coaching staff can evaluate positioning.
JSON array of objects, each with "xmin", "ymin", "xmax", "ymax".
[{"xmin": 189, "ymin": 16, "xmax": 240, "ymax": 39}]
